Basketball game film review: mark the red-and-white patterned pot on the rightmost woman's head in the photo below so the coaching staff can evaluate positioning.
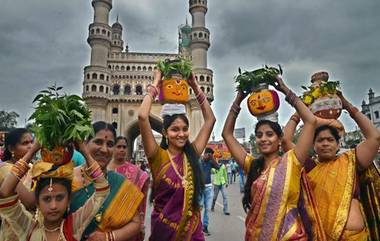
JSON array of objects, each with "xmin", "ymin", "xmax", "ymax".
[{"xmin": 309, "ymin": 95, "xmax": 342, "ymax": 119}]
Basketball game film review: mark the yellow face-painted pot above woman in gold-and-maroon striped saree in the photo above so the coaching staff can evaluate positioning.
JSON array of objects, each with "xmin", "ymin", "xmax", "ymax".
[{"xmin": 247, "ymin": 84, "xmax": 280, "ymax": 117}]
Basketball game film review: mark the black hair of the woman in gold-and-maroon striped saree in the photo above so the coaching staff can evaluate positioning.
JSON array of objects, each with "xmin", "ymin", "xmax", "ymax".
[{"xmin": 242, "ymin": 120, "xmax": 282, "ymax": 212}]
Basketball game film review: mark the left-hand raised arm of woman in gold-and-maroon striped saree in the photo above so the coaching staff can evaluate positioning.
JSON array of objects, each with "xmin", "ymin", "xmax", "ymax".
[{"xmin": 222, "ymin": 90, "xmax": 247, "ymax": 167}]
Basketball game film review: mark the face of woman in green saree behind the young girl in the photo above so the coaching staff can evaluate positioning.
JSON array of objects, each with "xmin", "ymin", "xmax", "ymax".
[{"xmin": 87, "ymin": 130, "xmax": 115, "ymax": 170}]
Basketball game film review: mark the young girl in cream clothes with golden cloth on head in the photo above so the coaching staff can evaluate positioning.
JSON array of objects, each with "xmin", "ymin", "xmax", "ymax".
[{"xmin": 0, "ymin": 139, "xmax": 109, "ymax": 241}]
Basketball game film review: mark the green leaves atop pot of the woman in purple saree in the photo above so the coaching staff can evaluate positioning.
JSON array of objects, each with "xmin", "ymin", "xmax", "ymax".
[{"xmin": 157, "ymin": 58, "xmax": 192, "ymax": 80}]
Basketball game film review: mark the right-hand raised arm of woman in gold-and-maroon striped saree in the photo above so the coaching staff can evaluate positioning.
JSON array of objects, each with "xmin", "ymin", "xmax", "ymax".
[{"xmin": 275, "ymin": 76, "xmax": 317, "ymax": 165}]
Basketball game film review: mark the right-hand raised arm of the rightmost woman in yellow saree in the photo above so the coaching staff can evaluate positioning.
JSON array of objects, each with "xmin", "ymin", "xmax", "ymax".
[{"xmin": 338, "ymin": 92, "xmax": 380, "ymax": 169}]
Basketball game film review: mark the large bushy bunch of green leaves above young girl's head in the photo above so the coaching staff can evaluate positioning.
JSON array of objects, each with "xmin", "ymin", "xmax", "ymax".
[{"xmin": 29, "ymin": 85, "xmax": 93, "ymax": 150}]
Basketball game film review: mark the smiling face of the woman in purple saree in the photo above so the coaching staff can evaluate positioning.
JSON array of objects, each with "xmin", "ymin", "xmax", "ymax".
[{"xmin": 164, "ymin": 117, "xmax": 190, "ymax": 149}]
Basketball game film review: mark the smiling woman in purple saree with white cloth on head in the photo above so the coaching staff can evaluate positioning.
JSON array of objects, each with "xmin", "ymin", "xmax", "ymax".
[{"xmin": 138, "ymin": 70, "xmax": 215, "ymax": 241}]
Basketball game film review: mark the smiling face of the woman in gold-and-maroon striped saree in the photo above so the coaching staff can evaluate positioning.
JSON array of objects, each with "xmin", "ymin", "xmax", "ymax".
[{"xmin": 256, "ymin": 124, "xmax": 281, "ymax": 155}]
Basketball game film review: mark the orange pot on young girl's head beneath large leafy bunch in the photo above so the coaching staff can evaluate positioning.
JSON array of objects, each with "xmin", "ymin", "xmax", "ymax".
[{"xmin": 41, "ymin": 146, "xmax": 74, "ymax": 166}]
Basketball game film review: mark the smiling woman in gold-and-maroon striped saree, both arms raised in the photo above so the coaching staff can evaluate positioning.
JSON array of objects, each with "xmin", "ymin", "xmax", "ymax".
[{"xmin": 222, "ymin": 76, "xmax": 325, "ymax": 241}]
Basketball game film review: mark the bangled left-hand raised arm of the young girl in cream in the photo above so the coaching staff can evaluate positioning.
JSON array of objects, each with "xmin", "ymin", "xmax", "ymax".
[{"xmin": 0, "ymin": 141, "xmax": 40, "ymax": 198}]
